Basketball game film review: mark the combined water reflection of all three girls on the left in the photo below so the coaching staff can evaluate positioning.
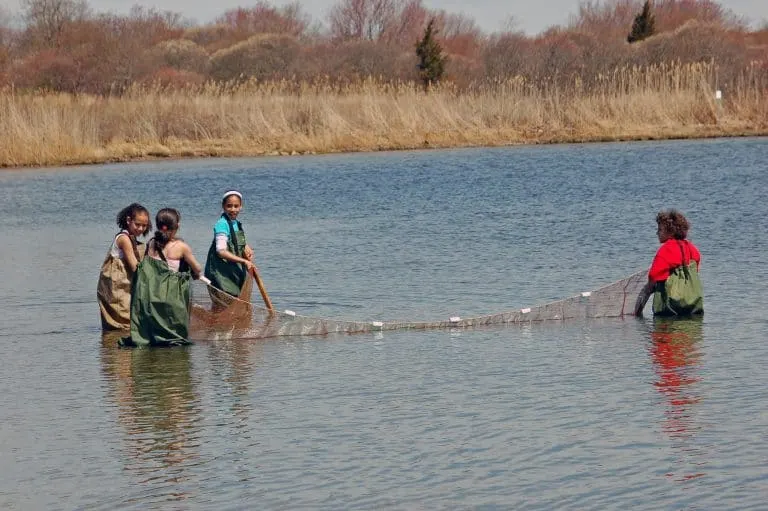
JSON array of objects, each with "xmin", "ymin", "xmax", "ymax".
[{"xmin": 101, "ymin": 333, "xmax": 262, "ymax": 503}]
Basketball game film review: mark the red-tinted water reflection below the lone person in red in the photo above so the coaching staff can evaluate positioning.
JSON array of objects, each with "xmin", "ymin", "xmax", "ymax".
[{"xmin": 649, "ymin": 317, "xmax": 704, "ymax": 480}]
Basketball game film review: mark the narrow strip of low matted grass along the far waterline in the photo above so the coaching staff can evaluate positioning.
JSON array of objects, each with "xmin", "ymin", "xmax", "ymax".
[{"xmin": 0, "ymin": 126, "xmax": 768, "ymax": 171}]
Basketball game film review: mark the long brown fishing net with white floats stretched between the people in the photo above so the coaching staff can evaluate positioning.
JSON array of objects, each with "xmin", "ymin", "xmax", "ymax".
[{"xmin": 189, "ymin": 270, "xmax": 647, "ymax": 340}]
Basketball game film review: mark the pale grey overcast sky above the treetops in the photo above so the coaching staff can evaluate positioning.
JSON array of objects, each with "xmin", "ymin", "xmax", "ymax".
[{"xmin": 0, "ymin": 0, "xmax": 768, "ymax": 35}]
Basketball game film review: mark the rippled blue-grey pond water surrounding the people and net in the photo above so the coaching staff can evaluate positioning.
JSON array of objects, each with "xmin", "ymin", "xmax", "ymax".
[{"xmin": 0, "ymin": 138, "xmax": 768, "ymax": 510}]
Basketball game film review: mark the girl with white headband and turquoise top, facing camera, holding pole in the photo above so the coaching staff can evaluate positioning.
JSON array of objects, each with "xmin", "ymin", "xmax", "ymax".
[{"xmin": 205, "ymin": 190, "xmax": 256, "ymax": 296}]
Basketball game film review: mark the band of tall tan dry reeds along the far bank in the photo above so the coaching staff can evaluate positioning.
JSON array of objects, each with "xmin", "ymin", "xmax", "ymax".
[{"xmin": 0, "ymin": 64, "xmax": 768, "ymax": 166}]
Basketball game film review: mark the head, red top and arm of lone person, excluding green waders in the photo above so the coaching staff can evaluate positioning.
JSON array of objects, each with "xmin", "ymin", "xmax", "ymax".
[{"xmin": 635, "ymin": 209, "xmax": 701, "ymax": 316}]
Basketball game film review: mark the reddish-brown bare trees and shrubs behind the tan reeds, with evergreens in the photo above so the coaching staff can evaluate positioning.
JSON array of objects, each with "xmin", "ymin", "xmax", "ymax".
[{"xmin": 0, "ymin": 0, "xmax": 768, "ymax": 94}]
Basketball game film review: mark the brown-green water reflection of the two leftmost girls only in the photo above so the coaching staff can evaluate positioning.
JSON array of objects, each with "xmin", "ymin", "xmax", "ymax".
[{"xmin": 101, "ymin": 335, "xmax": 201, "ymax": 499}]
